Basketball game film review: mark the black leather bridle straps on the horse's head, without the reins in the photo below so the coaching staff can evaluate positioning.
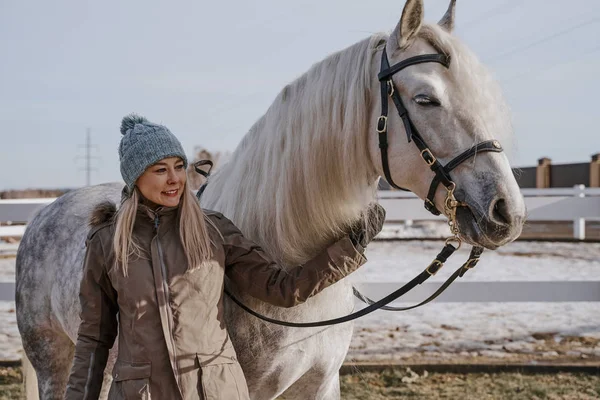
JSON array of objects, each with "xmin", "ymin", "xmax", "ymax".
[{"xmin": 377, "ymin": 48, "xmax": 502, "ymax": 235}]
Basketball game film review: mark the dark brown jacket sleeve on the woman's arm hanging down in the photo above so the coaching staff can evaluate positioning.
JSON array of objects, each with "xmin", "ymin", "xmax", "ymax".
[{"xmin": 65, "ymin": 236, "xmax": 118, "ymax": 400}]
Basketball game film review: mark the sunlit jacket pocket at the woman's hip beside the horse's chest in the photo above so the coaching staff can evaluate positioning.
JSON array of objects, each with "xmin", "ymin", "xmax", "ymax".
[{"xmin": 197, "ymin": 350, "xmax": 250, "ymax": 400}]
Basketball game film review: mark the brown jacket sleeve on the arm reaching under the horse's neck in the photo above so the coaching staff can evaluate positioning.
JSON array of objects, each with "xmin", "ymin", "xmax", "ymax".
[{"xmin": 219, "ymin": 217, "xmax": 367, "ymax": 307}]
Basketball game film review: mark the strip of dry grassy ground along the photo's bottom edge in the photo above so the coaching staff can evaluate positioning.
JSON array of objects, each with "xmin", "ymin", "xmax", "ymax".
[{"xmin": 0, "ymin": 368, "xmax": 600, "ymax": 400}]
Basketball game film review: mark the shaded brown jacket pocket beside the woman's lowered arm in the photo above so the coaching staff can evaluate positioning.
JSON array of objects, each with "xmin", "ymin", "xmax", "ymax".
[{"xmin": 108, "ymin": 361, "xmax": 152, "ymax": 400}]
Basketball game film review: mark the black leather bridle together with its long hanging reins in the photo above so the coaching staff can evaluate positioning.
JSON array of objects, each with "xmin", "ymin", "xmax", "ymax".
[{"xmin": 194, "ymin": 43, "xmax": 502, "ymax": 328}]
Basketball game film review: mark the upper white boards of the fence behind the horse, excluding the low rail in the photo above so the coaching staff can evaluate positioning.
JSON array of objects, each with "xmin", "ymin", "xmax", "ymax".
[{"xmin": 0, "ymin": 185, "xmax": 600, "ymax": 240}]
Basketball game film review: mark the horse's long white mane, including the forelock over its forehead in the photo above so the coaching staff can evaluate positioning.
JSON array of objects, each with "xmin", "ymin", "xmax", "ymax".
[{"xmin": 202, "ymin": 25, "xmax": 510, "ymax": 265}]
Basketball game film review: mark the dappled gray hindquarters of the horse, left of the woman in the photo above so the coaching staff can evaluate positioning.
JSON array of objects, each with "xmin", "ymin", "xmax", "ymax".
[{"xmin": 15, "ymin": 183, "xmax": 122, "ymax": 399}]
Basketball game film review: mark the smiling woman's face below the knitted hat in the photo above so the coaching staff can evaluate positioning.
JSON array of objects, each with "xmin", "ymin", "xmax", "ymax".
[{"xmin": 136, "ymin": 157, "xmax": 187, "ymax": 207}]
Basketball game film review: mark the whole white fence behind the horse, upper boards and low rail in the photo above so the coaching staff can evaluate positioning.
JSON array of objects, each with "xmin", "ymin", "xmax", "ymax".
[{"xmin": 0, "ymin": 186, "xmax": 600, "ymax": 302}]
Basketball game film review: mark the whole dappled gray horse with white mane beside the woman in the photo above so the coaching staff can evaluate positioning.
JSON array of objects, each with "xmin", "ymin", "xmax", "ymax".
[{"xmin": 16, "ymin": 0, "xmax": 525, "ymax": 400}]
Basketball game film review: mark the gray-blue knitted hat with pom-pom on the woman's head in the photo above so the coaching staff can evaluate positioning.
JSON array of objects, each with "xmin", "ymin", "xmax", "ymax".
[{"xmin": 119, "ymin": 114, "xmax": 187, "ymax": 193}]
